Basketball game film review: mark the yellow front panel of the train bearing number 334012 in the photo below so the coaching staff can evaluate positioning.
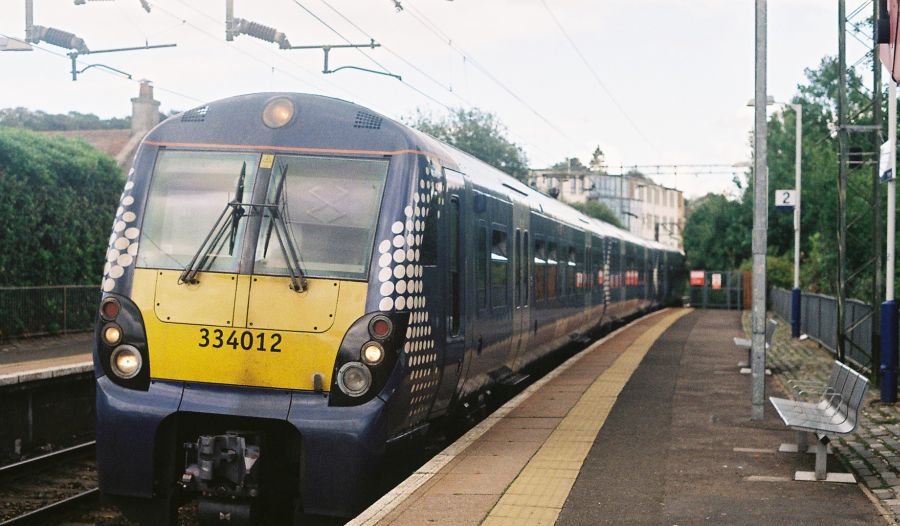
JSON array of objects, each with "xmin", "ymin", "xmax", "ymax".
[{"xmin": 132, "ymin": 269, "xmax": 367, "ymax": 390}]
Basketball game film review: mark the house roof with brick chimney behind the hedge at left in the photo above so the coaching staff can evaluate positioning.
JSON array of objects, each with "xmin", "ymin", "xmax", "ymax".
[{"xmin": 46, "ymin": 80, "xmax": 159, "ymax": 171}]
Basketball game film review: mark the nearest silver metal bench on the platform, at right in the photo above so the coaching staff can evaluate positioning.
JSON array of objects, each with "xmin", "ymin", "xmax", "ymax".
[{"xmin": 769, "ymin": 362, "xmax": 869, "ymax": 484}]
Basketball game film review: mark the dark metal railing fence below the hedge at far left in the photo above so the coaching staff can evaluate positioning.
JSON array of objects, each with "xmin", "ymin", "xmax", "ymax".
[{"xmin": 0, "ymin": 285, "xmax": 100, "ymax": 341}]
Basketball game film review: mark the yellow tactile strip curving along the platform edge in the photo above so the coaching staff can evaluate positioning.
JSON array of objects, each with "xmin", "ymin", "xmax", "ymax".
[{"xmin": 482, "ymin": 309, "xmax": 691, "ymax": 526}]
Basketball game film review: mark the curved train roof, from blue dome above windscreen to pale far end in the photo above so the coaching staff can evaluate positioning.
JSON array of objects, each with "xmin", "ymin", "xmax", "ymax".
[{"xmin": 158, "ymin": 92, "xmax": 679, "ymax": 258}]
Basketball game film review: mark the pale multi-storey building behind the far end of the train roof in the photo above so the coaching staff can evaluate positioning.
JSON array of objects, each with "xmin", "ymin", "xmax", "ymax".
[{"xmin": 528, "ymin": 169, "xmax": 685, "ymax": 249}]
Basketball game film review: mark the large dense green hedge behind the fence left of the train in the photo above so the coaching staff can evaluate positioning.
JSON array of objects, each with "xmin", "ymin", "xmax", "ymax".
[{"xmin": 0, "ymin": 126, "xmax": 123, "ymax": 286}]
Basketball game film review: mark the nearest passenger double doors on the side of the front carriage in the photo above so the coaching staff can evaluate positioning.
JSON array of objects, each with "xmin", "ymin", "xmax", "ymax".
[{"xmin": 510, "ymin": 202, "xmax": 533, "ymax": 370}]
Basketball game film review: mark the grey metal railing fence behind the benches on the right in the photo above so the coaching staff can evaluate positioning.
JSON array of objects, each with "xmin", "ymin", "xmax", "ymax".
[{"xmin": 771, "ymin": 288, "xmax": 872, "ymax": 371}]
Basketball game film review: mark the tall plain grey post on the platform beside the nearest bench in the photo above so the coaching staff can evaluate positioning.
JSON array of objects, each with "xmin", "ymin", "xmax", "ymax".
[{"xmin": 750, "ymin": 0, "xmax": 769, "ymax": 420}]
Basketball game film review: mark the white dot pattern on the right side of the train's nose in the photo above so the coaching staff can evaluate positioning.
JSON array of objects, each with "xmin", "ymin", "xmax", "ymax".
[{"xmin": 378, "ymin": 161, "xmax": 444, "ymax": 425}]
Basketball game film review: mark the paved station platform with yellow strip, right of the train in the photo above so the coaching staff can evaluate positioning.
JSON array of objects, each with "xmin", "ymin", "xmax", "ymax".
[{"xmin": 350, "ymin": 309, "xmax": 892, "ymax": 526}]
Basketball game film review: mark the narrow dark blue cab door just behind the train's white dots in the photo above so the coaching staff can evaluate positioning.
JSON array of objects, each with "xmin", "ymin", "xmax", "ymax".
[{"xmin": 432, "ymin": 168, "xmax": 471, "ymax": 413}]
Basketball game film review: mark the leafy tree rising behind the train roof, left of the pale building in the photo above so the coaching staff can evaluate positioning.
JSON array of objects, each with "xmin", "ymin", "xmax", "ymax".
[{"xmin": 403, "ymin": 108, "xmax": 528, "ymax": 182}]
